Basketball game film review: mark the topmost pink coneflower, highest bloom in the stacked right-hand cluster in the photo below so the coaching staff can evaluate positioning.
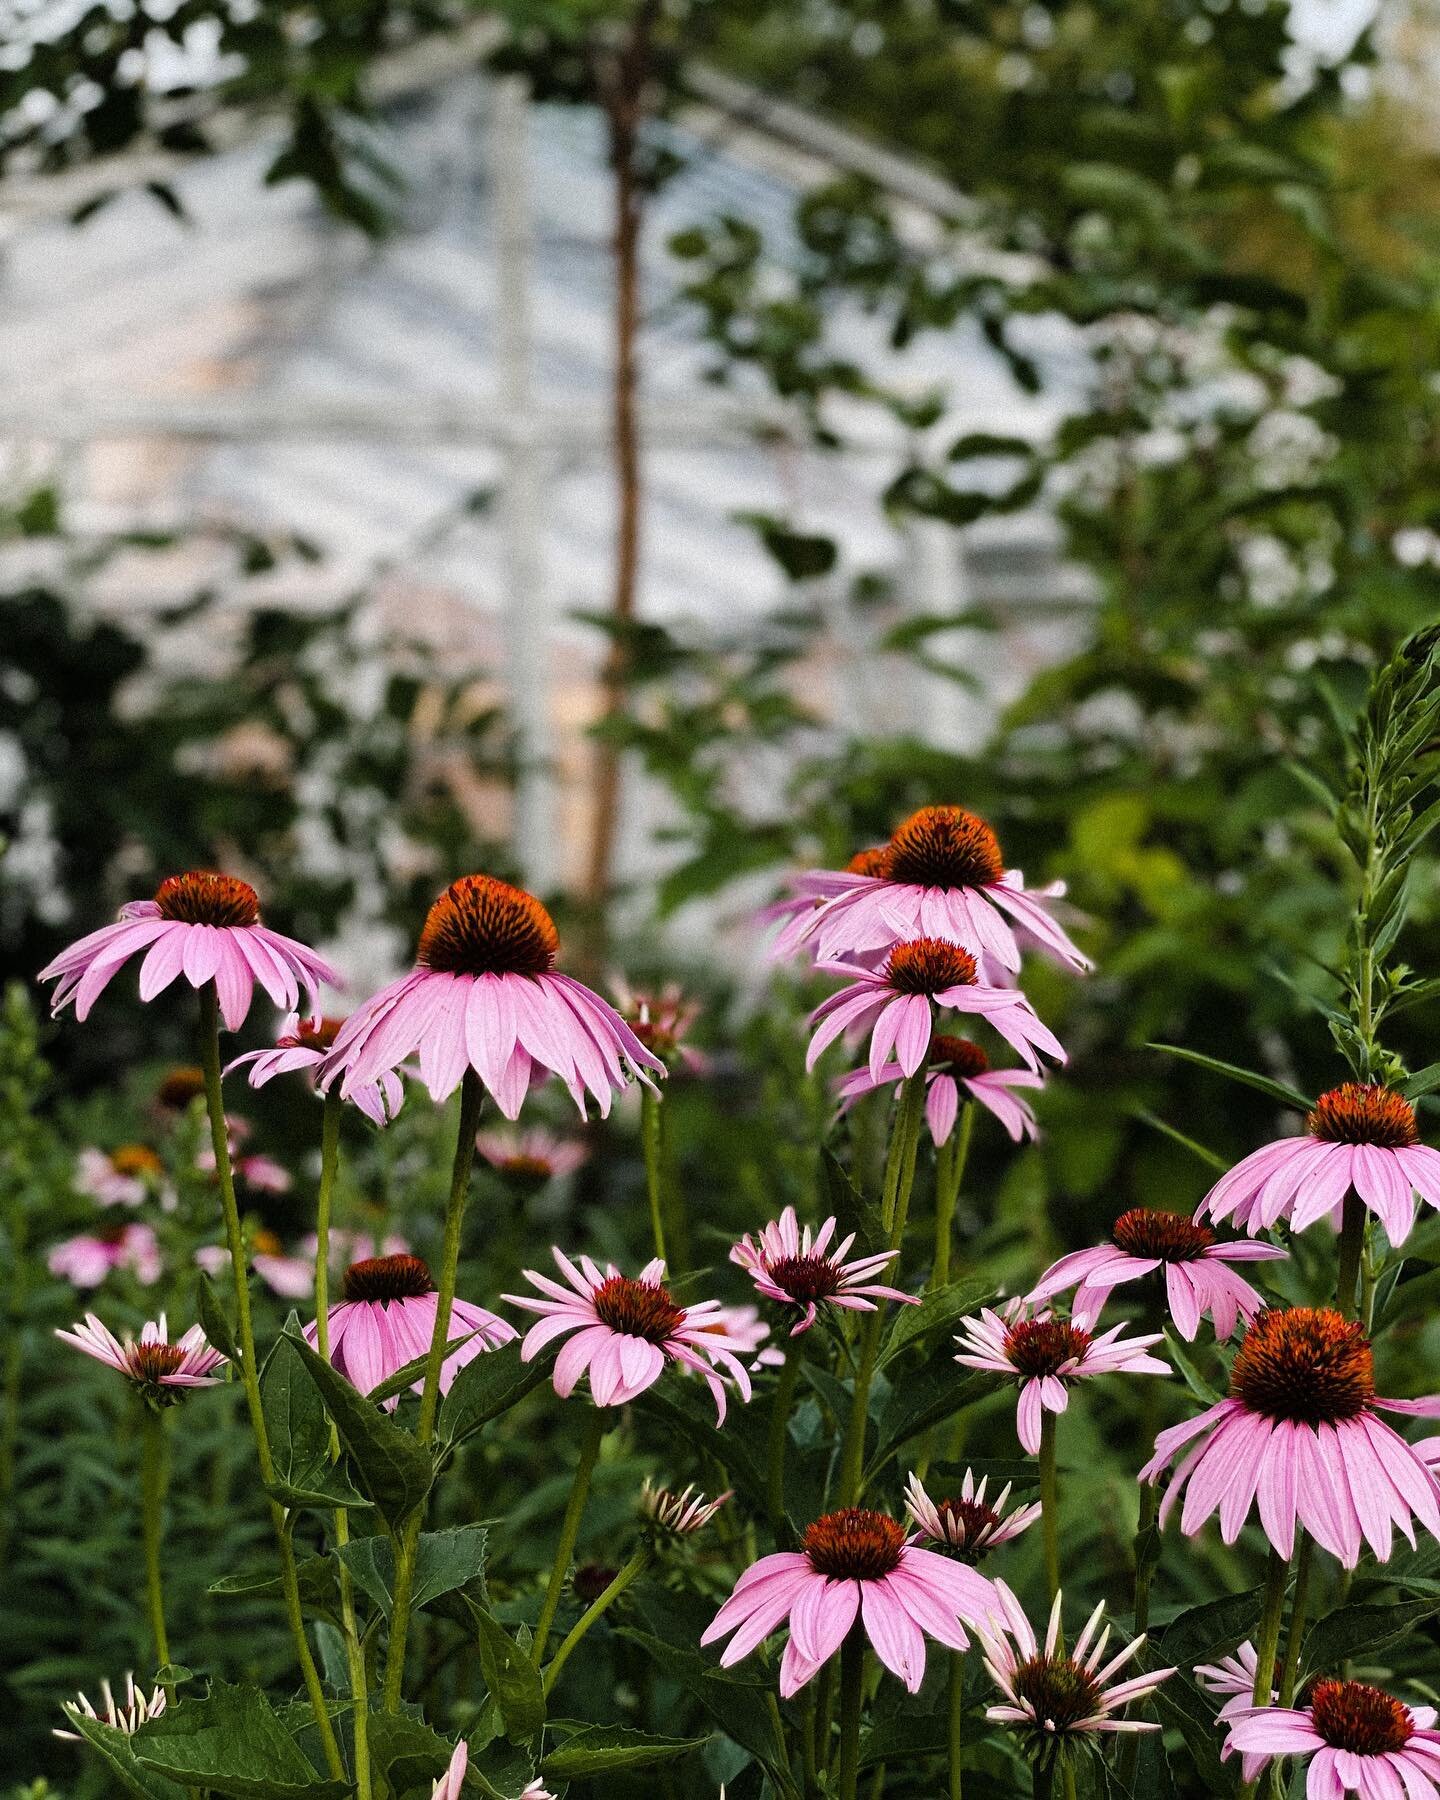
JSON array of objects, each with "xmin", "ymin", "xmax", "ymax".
[{"xmin": 794, "ymin": 806, "xmax": 1089, "ymax": 970}]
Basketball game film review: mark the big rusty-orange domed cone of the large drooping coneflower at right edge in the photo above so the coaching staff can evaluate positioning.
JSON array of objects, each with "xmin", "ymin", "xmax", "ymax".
[{"xmin": 1229, "ymin": 1307, "xmax": 1375, "ymax": 1426}]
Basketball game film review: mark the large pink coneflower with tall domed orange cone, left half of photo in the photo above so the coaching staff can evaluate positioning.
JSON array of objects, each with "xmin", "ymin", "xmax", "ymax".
[{"xmin": 320, "ymin": 875, "xmax": 664, "ymax": 1120}]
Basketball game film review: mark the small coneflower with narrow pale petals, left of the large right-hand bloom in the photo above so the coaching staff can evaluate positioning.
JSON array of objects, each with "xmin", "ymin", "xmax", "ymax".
[{"xmin": 956, "ymin": 1300, "xmax": 1170, "ymax": 1456}]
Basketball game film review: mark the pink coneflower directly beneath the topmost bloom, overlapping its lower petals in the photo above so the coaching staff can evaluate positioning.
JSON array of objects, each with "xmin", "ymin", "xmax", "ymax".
[{"xmin": 805, "ymin": 938, "xmax": 1066, "ymax": 1082}]
